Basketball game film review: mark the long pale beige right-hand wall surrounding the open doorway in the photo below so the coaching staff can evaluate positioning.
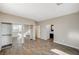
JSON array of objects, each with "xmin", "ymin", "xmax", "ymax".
[{"xmin": 39, "ymin": 12, "xmax": 79, "ymax": 49}]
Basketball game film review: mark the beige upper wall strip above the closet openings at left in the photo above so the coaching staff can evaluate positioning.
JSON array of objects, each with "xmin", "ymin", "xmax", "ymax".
[{"xmin": 0, "ymin": 12, "xmax": 35, "ymax": 25}]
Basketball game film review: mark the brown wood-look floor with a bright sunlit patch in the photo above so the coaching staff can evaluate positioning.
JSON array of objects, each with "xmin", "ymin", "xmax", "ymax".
[{"xmin": 0, "ymin": 39, "xmax": 79, "ymax": 55}]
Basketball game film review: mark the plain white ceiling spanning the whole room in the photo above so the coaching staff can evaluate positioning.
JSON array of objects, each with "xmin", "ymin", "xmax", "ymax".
[{"xmin": 0, "ymin": 3, "xmax": 79, "ymax": 21}]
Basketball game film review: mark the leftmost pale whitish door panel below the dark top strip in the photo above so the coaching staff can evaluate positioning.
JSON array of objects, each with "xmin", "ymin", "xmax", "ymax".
[{"xmin": 1, "ymin": 23, "xmax": 12, "ymax": 46}]
